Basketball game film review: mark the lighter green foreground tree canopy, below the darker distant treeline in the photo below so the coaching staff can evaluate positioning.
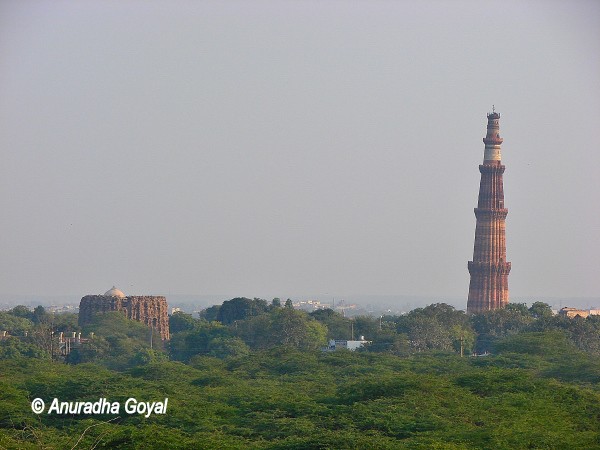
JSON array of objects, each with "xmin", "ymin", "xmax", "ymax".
[{"xmin": 0, "ymin": 328, "xmax": 600, "ymax": 450}]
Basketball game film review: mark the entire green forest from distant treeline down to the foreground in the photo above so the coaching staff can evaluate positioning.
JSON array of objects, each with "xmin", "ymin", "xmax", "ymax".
[{"xmin": 0, "ymin": 298, "xmax": 600, "ymax": 449}]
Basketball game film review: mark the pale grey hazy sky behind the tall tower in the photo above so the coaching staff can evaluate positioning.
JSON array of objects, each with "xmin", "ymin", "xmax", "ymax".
[{"xmin": 0, "ymin": 0, "xmax": 600, "ymax": 303}]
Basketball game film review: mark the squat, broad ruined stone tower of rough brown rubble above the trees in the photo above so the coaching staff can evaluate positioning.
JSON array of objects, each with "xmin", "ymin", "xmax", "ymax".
[{"xmin": 79, "ymin": 286, "xmax": 169, "ymax": 340}]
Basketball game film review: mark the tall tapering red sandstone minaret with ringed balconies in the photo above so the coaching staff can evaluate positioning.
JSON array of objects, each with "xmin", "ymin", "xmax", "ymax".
[{"xmin": 467, "ymin": 110, "xmax": 510, "ymax": 313}]
